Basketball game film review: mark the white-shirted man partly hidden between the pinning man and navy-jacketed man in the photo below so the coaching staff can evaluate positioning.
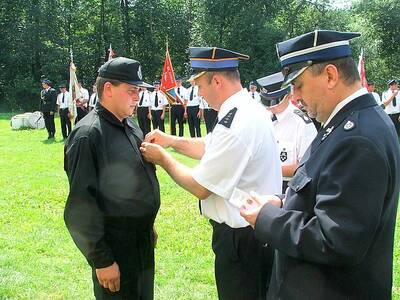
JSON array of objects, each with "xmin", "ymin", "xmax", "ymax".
[{"xmin": 257, "ymin": 72, "xmax": 317, "ymax": 193}]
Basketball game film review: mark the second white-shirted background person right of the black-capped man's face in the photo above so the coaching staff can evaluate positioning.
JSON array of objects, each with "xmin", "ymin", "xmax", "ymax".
[{"xmin": 150, "ymin": 81, "xmax": 168, "ymax": 132}]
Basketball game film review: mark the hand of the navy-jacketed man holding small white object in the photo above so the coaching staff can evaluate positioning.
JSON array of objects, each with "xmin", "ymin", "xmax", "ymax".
[{"xmin": 240, "ymin": 192, "xmax": 282, "ymax": 228}]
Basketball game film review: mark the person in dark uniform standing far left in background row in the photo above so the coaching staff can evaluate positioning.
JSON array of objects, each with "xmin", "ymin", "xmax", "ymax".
[{"xmin": 40, "ymin": 79, "xmax": 57, "ymax": 139}]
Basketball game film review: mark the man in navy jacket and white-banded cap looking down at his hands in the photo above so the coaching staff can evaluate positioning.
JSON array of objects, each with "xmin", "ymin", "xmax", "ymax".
[{"xmin": 242, "ymin": 30, "xmax": 400, "ymax": 300}]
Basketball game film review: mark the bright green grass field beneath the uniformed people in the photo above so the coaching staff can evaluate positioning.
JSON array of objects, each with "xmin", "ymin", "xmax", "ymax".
[{"xmin": 0, "ymin": 114, "xmax": 400, "ymax": 300}]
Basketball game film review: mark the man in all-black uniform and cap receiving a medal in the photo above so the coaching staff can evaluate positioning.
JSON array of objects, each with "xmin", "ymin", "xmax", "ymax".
[{"xmin": 64, "ymin": 57, "xmax": 160, "ymax": 299}]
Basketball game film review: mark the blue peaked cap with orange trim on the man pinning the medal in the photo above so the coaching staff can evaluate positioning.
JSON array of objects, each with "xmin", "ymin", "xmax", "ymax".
[{"xmin": 189, "ymin": 47, "xmax": 249, "ymax": 80}]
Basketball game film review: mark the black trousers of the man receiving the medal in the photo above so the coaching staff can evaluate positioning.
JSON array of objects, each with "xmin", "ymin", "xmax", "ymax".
[{"xmin": 92, "ymin": 219, "xmax": 155, "ymax": 300}]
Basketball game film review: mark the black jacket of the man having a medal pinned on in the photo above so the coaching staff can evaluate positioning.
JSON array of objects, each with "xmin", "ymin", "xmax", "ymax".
[{"xmin": 64, "ymin": 103, "xmax": 160, "ymax": 268}]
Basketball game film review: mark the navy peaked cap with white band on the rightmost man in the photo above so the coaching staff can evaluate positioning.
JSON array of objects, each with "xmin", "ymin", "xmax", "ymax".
[{"xmin": 276, "ymin": 30, "xmax": 361, "ymax": 86}]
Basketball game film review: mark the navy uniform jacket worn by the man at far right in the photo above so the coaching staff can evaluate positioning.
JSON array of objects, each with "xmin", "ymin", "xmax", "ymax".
[{"xmin": 255, "ymin": 94, "xmax": 400, "ymax": 300}]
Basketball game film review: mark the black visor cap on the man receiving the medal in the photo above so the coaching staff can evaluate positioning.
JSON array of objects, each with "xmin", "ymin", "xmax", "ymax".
[{"xmin": 99, "ymin": 57, "xmax": 153, "ymax": 88}]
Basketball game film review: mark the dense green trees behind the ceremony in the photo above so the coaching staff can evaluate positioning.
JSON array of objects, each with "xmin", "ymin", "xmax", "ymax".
[{"xmin": 0, "ymin": 0, "xmax": 400, "ymax": 110}]
